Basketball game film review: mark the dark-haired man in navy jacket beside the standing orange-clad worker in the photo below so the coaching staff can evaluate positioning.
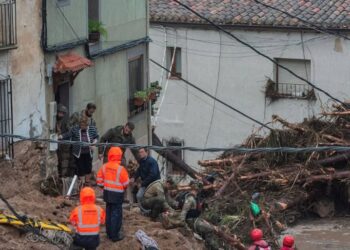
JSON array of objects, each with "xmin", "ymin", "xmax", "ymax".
[{"xmin": 130, "ymin": 148, "xmax": 160, "ymax": 204}]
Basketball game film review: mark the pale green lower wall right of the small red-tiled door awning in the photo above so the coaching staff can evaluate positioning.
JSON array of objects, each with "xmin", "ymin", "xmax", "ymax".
[{"xmin": 46, "ymin": 45, "xmax": 147, "ymax": 143}]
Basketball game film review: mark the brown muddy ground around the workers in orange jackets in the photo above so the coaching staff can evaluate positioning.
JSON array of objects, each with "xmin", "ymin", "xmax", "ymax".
[{"xmin": 0, "ymin": 142, "xmax": 205, "ymax": 250}]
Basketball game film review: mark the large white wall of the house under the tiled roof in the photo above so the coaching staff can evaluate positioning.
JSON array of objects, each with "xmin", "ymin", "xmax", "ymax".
[{"xmin": 150, "ymin": 25, "xmax": 350, "ymax": 169}]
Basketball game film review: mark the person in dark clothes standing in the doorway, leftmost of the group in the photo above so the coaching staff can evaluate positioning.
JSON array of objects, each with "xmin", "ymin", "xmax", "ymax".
[{"xmin": 55, "ymin": 104, "xmax": 72, "ymax": 177}]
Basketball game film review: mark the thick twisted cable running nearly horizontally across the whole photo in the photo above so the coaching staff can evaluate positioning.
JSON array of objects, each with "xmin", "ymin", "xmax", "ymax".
[{"xmin": 0, "ymin": 134, "xmax": 350, "ymax": 154}]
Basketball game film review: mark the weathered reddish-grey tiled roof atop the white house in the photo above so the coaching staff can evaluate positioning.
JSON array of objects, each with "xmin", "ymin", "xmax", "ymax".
[{"xmin": 149, "ymin": 0, "xmax": 350, "ymax": 30}]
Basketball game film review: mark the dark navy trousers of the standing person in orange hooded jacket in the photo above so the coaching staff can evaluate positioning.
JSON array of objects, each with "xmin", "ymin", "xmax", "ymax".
[{"xmin": 106, "ymin": 202, "xmax": 123, "ymax": 240}]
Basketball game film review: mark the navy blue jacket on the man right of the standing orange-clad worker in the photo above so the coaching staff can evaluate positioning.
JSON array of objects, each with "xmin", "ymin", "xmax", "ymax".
[{"xmin": 134, "ymin": 156, "xmax": 160, "ymax": 187}]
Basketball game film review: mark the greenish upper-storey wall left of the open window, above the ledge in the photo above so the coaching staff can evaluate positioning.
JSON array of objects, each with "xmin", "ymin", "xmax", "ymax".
[{"xmin": 46, "ymin": 0, "xmax": 88, "ymax": 46}]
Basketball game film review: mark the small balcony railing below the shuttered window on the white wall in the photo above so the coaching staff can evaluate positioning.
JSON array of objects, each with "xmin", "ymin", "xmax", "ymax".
[{"xmin": 266, "ymin": 83, "xmax": 315, "ymax": 99}]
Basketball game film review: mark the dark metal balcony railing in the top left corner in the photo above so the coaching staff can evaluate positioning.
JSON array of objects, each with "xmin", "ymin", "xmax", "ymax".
[{"xmin": 0, "ymin": 0, "xmax": 17, "ymax": 49}]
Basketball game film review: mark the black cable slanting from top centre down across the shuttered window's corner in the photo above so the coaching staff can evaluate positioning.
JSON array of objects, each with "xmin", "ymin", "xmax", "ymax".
[{"xmin": 172, "ymin": 0, "xmax": 346, "ymax": 105}]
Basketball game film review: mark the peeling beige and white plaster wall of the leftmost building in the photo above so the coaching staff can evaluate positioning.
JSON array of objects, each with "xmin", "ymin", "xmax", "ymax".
[{"xmin": 0, "ymin": 0, "xmax": 46, "ymax": 136}]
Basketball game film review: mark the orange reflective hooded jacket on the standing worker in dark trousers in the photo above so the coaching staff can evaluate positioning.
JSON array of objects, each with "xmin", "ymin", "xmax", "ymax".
[{"xmin": 96, "ymin": 147, "xmax": 129, "ymax": 193}]
